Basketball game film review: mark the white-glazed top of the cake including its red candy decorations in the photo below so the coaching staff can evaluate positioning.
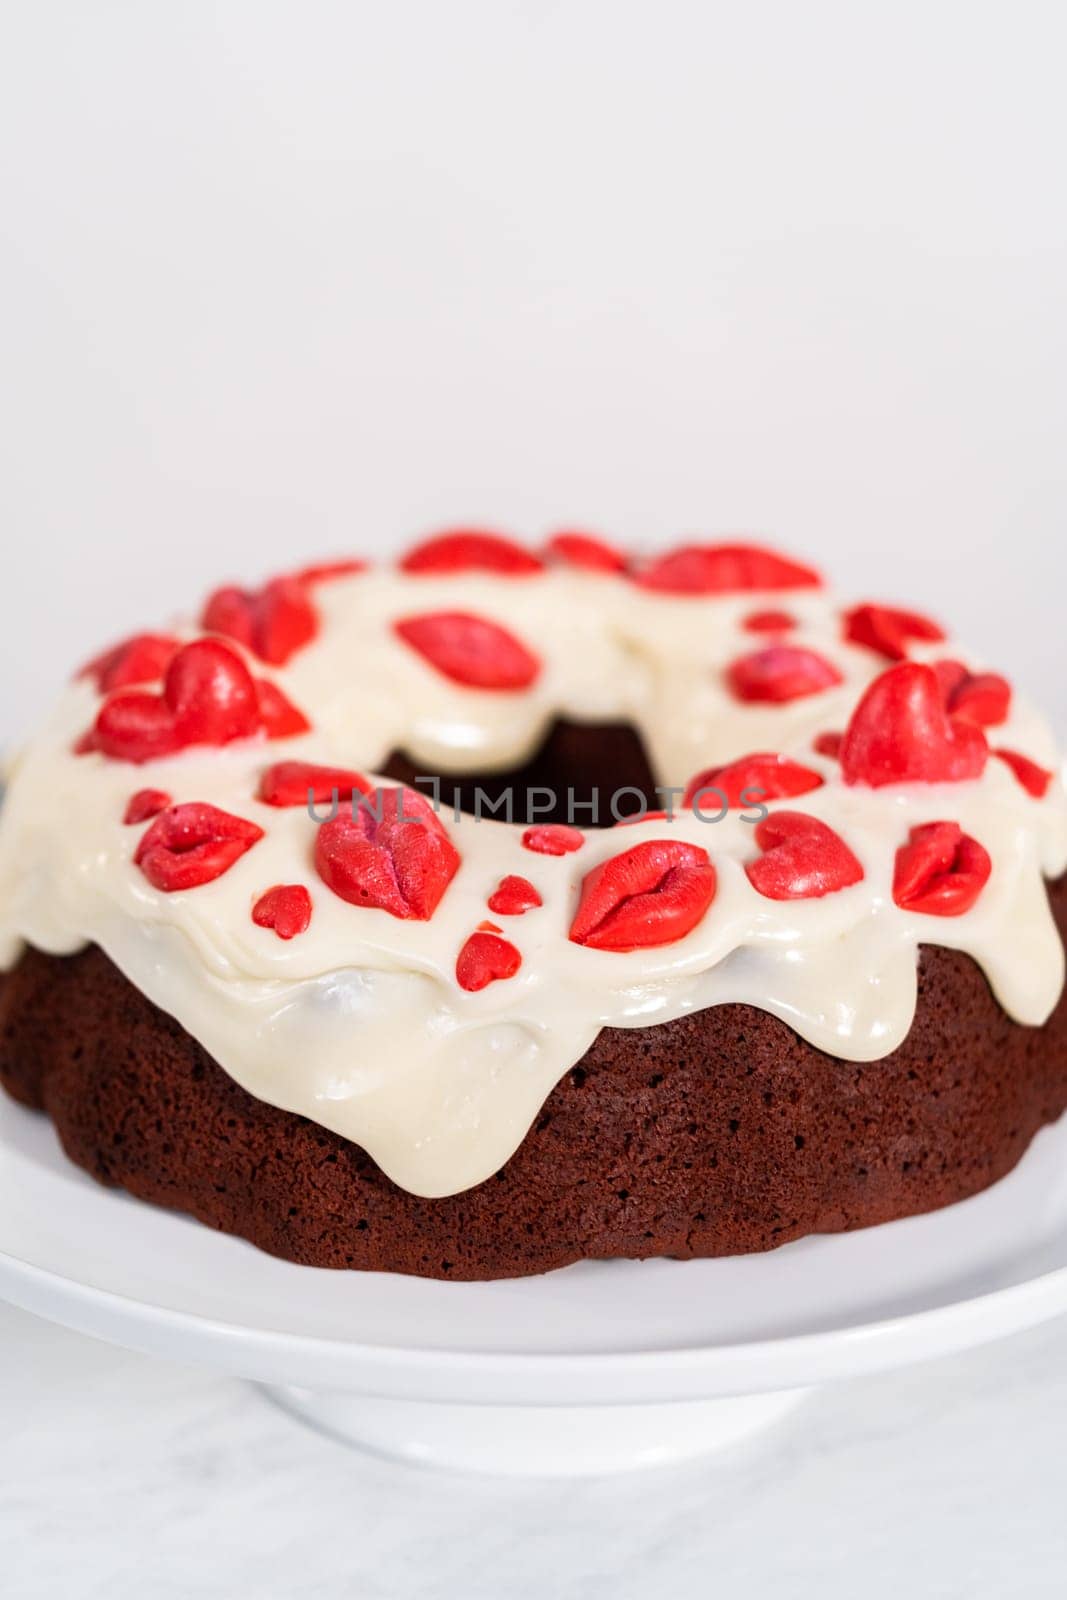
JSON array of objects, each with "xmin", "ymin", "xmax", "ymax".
[{"xmin": 0, "ymin": 530, "xmax": 1067, "ymax": 1195}]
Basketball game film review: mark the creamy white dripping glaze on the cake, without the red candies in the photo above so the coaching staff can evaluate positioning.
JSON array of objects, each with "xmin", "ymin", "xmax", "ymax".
[{"xmin": 0, "ymin": 570, "xmax": 1067, "ymax": 1195}]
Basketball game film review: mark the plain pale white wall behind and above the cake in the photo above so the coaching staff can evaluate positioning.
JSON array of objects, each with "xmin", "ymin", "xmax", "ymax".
[{"xmin": 0, "ymin": 0, "xmax": 1067, "ymax": 736}]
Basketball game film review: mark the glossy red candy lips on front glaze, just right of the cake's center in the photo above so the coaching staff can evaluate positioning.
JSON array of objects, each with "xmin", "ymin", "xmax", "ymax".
[{"xmin": 568, "ymin": 838, "xmax": 717, "ymax": 950}]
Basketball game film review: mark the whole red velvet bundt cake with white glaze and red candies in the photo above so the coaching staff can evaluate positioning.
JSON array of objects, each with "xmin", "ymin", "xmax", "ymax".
[{"xmin": 0, "ymin": 531, "xmax": 1067, "ymax": 1278}]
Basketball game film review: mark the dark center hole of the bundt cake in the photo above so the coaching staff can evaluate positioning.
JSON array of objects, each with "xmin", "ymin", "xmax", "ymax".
[{"xmin": 386, "ymin": 718, "xmax": 662, "ymax": 827}]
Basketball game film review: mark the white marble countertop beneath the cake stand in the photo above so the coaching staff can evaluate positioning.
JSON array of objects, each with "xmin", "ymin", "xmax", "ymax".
[{"xmin": 0, "ymin": 1307, "xmax": 1067, "ymax": 1600}]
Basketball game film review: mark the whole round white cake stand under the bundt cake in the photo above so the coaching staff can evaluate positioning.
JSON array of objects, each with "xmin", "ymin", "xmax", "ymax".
[{"xmin": 0, "ymin": 1096, "xmax": 1067, "ymax": 1474}]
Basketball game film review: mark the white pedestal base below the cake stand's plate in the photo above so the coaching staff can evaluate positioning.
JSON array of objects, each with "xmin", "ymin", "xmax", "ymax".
[{"xmin": 258, "ymin": 1384, "xmax": 811, "ymax": 1477}]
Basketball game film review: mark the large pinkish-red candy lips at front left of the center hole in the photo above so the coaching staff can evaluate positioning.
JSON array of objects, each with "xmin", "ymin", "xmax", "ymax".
[{"xmin": 315, "ymin": 789, "xmax": 459, "ymax": 922}]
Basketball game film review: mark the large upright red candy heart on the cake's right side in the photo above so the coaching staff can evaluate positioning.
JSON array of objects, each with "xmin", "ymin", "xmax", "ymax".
[{"xmin": 840, "ymin": 661, "xmax": 989, "ymax": 789}]
